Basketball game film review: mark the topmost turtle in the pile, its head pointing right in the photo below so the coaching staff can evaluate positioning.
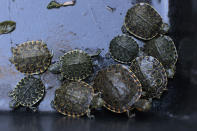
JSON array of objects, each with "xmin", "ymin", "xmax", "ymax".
[{"xmin": 124, "ymin": 3, "xmax": 169, "ymax": 40}]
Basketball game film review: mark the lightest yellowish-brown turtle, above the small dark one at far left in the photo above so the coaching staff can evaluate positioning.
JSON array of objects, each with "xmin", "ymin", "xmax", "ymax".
[{"xmin": 10, "ymin": 41, "xmax": 53, "ymax": 74}]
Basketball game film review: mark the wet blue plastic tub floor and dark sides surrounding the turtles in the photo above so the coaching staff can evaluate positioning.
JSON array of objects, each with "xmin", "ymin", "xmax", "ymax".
[{"xmin": 0, "ymin": 0, "xmax": 197, "ymax": 131}]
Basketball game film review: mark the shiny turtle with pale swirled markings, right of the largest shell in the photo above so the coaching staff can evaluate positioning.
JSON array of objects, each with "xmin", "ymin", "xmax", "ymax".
[{"xmin": 131, "ymin": 56, "xmax": 167, "ymax": 98}]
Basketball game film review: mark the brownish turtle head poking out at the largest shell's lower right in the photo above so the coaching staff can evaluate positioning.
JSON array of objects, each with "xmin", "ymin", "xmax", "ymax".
[{"xmin": 134, "ymin": 99, "xmax": 152, "ymax": 112}]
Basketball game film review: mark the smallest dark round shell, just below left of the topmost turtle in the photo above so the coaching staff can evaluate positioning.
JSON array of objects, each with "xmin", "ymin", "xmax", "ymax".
[{"xmin": 109, "ymin": 35, "xmax": 139, "ymax": 63}]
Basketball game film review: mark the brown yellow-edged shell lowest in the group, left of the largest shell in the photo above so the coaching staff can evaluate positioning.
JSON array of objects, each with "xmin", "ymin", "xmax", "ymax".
[{"xmin": 53, "ymin": 81, "xmax": 94, "ymax": 117}]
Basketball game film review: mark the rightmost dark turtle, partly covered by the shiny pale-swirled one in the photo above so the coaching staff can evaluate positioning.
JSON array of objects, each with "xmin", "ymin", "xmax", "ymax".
[{"xmin": 144, "ymin": 35, "xmax": 178, "ymax": 78}]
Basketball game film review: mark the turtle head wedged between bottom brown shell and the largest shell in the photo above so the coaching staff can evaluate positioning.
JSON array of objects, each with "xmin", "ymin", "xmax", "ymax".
[{"xmin": 91, "ymin": 92, "xmax": 104, "ymax": 109}]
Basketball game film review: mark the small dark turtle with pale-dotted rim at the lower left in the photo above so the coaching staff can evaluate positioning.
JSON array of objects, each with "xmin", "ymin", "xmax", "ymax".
[{"xmin": 9, "ymin": 76, "xmax": 45, "ymax": 111}]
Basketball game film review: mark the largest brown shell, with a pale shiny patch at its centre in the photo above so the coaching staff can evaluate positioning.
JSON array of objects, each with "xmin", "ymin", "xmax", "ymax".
[{"xmin": 93, "ymin": 64, "xmax": 142, "ymax": 113}]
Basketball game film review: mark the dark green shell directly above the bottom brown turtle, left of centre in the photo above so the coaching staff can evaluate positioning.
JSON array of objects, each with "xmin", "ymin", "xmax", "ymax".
[{"xmin": 60, "ymin": 50, "xmax": 93, "ymax": 80}]
